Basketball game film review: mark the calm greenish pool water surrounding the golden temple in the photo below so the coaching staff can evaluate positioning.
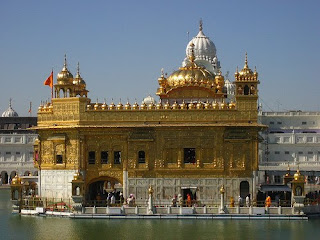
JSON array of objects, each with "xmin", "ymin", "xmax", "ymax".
[{"xmin": 0, "ymin": 189, "xmax": 320, "ymax": 240}]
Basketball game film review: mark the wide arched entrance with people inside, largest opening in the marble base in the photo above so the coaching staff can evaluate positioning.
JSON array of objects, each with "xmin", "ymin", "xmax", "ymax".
[{"xmin": 86, "ymin": 177, "xmax": 122, "ymax": 206}]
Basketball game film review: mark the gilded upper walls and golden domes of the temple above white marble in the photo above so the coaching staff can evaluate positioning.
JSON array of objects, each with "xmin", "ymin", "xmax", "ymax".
[{"xmin": 35, "ymin": 26, "xmax": 263, "ymax": 201}]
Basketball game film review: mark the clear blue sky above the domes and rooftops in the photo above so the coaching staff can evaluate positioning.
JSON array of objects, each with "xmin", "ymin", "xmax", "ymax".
[{"xmin": 0, "ymin": 0, "xmax": 320, "ymax": 116}]
